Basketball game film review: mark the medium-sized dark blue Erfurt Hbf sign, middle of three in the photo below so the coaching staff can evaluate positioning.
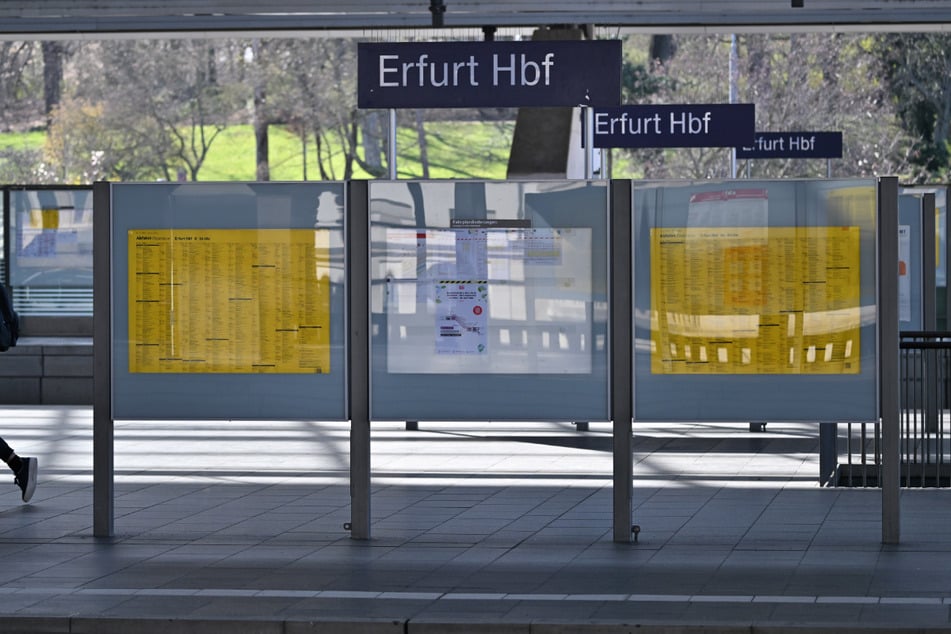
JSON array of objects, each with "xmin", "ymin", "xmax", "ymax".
[{"xmin": 594, "ymin": 103, "xmax": 756, "ymax": 148}]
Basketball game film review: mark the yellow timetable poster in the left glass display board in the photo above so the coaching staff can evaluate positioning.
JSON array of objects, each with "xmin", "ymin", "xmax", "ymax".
[{"xmin": 129, "ymin": 229, "xmax": 330, "ymax": 374}]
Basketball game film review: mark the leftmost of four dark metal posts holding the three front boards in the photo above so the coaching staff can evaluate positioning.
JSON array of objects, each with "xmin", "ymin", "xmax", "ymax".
[{"xmin": 92, "ymin": 182, "xmax": 115, "ymax": 537}]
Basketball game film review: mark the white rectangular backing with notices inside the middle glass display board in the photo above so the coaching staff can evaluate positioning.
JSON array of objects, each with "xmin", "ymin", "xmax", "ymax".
[{"xmin": 381, "ymin": 227, "xmax": 592, "ymax": 374}]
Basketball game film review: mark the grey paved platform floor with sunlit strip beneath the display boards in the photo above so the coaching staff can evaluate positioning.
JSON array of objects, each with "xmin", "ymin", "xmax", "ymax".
[{"xmin": 0, "ymin": 407, "xmax": 951, "ymax": 634}]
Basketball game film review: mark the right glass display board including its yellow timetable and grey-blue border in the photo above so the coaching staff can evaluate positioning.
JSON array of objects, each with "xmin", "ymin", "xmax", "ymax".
[{"xmin": 633, "ymin": 180, "xmax": 877, "ymax": 422}]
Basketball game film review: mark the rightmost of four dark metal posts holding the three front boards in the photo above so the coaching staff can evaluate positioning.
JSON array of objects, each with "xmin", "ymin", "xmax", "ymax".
[{"xmin": 878, "ymin": 176, "xmax": 901, "ymax": 544}]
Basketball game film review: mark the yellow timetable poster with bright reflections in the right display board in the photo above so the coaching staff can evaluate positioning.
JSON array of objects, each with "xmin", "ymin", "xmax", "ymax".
[{"xmin": 651, "ymin": 227, "xmax": 861, "ymax": 374}]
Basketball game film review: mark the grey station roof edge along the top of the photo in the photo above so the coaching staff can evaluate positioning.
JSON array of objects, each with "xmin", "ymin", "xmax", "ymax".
[{"xmin": 0, "ymin": 0, "xmax": 951, "ymax": 40}]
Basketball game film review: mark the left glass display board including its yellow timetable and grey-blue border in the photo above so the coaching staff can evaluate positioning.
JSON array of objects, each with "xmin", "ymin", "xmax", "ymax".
[{"xmin": 111, "ymin": 183, "xmax": 346, "ymax": 420}]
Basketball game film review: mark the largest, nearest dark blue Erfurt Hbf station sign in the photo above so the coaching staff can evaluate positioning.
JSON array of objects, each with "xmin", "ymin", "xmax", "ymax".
[{"xmin": 357, "ymin": 40, "xmax": 621, "ymax": 108}]
